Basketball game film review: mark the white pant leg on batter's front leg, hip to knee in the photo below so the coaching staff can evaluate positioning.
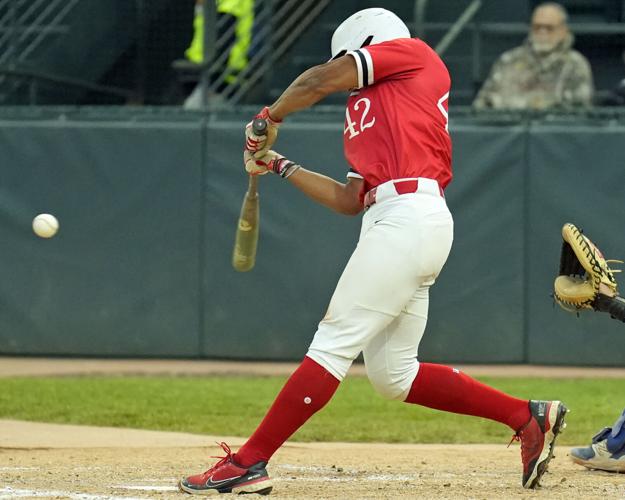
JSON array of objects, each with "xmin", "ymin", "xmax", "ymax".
[{"xmin": 308, "ymin": 195, "xmax": 453, "ymax": 378}]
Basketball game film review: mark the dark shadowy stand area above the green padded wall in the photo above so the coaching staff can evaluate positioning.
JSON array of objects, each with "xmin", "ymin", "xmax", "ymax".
[{"xmin": 0, "ymin": 0, "xmax": 625, "ymax": 105}]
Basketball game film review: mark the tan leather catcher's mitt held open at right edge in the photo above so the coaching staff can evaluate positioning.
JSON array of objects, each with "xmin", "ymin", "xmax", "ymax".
[{"xmin": 554, "ymin": 223, "xmax": 625, "ymax": 321}]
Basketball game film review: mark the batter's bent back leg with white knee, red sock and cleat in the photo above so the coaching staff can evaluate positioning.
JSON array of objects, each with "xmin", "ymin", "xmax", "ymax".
[{"xmin": 364, "ymin": 287, "xmax": 567, "ymax": 488}]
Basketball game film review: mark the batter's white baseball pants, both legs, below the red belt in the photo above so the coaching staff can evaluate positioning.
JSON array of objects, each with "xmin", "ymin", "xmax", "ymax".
[{"xmin": 307, "ymin": 178, "xmax": 453, "ymax": 400}]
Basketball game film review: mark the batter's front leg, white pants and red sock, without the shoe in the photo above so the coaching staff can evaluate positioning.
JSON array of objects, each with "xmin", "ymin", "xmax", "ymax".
[{"xmin": 236, "ymin": 193, "xmax": 453, "ymax": 470}]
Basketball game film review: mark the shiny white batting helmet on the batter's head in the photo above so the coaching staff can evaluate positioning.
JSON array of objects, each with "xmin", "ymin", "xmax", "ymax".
[{"xmin": 332, "ymin": 7, "xmax": 410, "ymax": 59}]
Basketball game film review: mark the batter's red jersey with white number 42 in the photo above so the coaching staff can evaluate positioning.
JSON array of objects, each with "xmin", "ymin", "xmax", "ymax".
[{"xmin": 343, "ymin": 38, "xmax": 452, "ymax": 195}]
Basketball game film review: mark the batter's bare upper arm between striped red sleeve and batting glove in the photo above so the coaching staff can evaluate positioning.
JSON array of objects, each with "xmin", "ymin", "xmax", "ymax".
[{"xmin": 269, "ymin": 57, "xmax": 358, "ymax": 121}]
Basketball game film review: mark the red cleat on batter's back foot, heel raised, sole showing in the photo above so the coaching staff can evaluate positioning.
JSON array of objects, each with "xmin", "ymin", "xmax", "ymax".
[{"xmin": 510, "ymin": 401, "xmax": 569, "ymax": 488}]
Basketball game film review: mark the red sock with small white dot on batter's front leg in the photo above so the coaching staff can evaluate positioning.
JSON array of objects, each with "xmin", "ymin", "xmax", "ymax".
[{"xmin": 234, "ymin": 357, "xmax": 339, "ymax": 467}]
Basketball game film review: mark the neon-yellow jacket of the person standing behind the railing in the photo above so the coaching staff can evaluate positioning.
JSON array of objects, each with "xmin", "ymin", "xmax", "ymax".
[{"xmin": 184, "ymin": 0, "xmax": 254, "ymax": 83}]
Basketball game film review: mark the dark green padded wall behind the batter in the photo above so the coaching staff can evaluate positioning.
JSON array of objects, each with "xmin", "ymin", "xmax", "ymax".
[{"xmin": 0, "ymin": 109, "xmax": 625, "ymax": 365}]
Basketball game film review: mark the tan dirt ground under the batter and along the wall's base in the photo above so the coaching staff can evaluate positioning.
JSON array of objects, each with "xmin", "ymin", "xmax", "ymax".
[{"xmin": 0, "ymin": 358, "xmax": 625, "ymax": 500}]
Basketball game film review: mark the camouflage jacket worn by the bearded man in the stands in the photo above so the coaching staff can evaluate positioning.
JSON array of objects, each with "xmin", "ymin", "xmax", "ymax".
[{"xmin": 473, "ymin": 35, "xmax": 593, "ymax": 109}]
